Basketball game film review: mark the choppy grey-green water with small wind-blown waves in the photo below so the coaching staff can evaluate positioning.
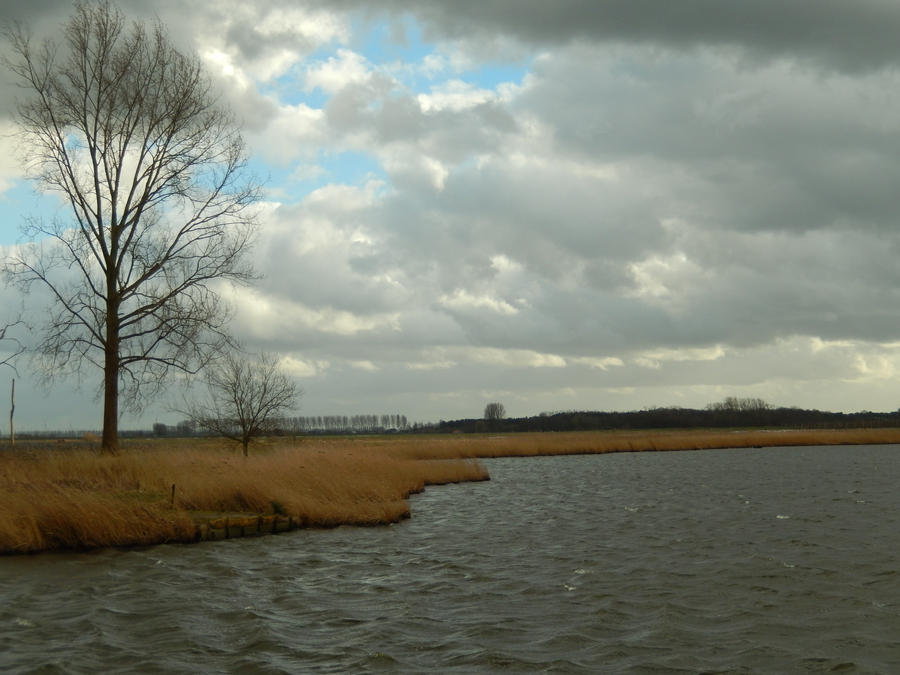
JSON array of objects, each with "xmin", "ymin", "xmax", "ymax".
[{"xmin": 0, "ymin": 446, "xmax": 900, "ymax": 673}]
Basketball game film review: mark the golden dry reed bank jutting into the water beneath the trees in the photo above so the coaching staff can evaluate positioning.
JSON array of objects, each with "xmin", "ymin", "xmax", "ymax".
[{"xmin": 0, "ymin": 441, "xmax": 488, "ymax": 553}]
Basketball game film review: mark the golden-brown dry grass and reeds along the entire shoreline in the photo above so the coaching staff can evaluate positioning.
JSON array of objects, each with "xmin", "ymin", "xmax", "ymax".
[{"xmin": 0, "ymin": 429, "xmax": 900, "ymax": 553}]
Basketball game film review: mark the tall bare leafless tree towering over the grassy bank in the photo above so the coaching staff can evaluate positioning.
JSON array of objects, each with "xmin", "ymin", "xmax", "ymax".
[{"xmin": 6, "ymin": 2, "xmax": 258, "ymax": 452}]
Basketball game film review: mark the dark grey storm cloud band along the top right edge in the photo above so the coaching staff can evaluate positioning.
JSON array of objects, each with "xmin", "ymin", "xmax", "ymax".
[{"xmin": 320, "ymin": 0, "xmax": 900, "ymax": 71}]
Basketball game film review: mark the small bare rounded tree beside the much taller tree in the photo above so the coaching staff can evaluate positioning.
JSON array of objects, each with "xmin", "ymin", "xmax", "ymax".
[{"xmin": 182, "ymin": 352, "xmax": 300, "ymax": 457}]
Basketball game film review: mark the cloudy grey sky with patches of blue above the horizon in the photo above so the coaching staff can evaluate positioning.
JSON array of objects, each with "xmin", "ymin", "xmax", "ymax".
[{"xmin": 0, "ymin": 0, "xmax": 900, "ymax": 430}]
